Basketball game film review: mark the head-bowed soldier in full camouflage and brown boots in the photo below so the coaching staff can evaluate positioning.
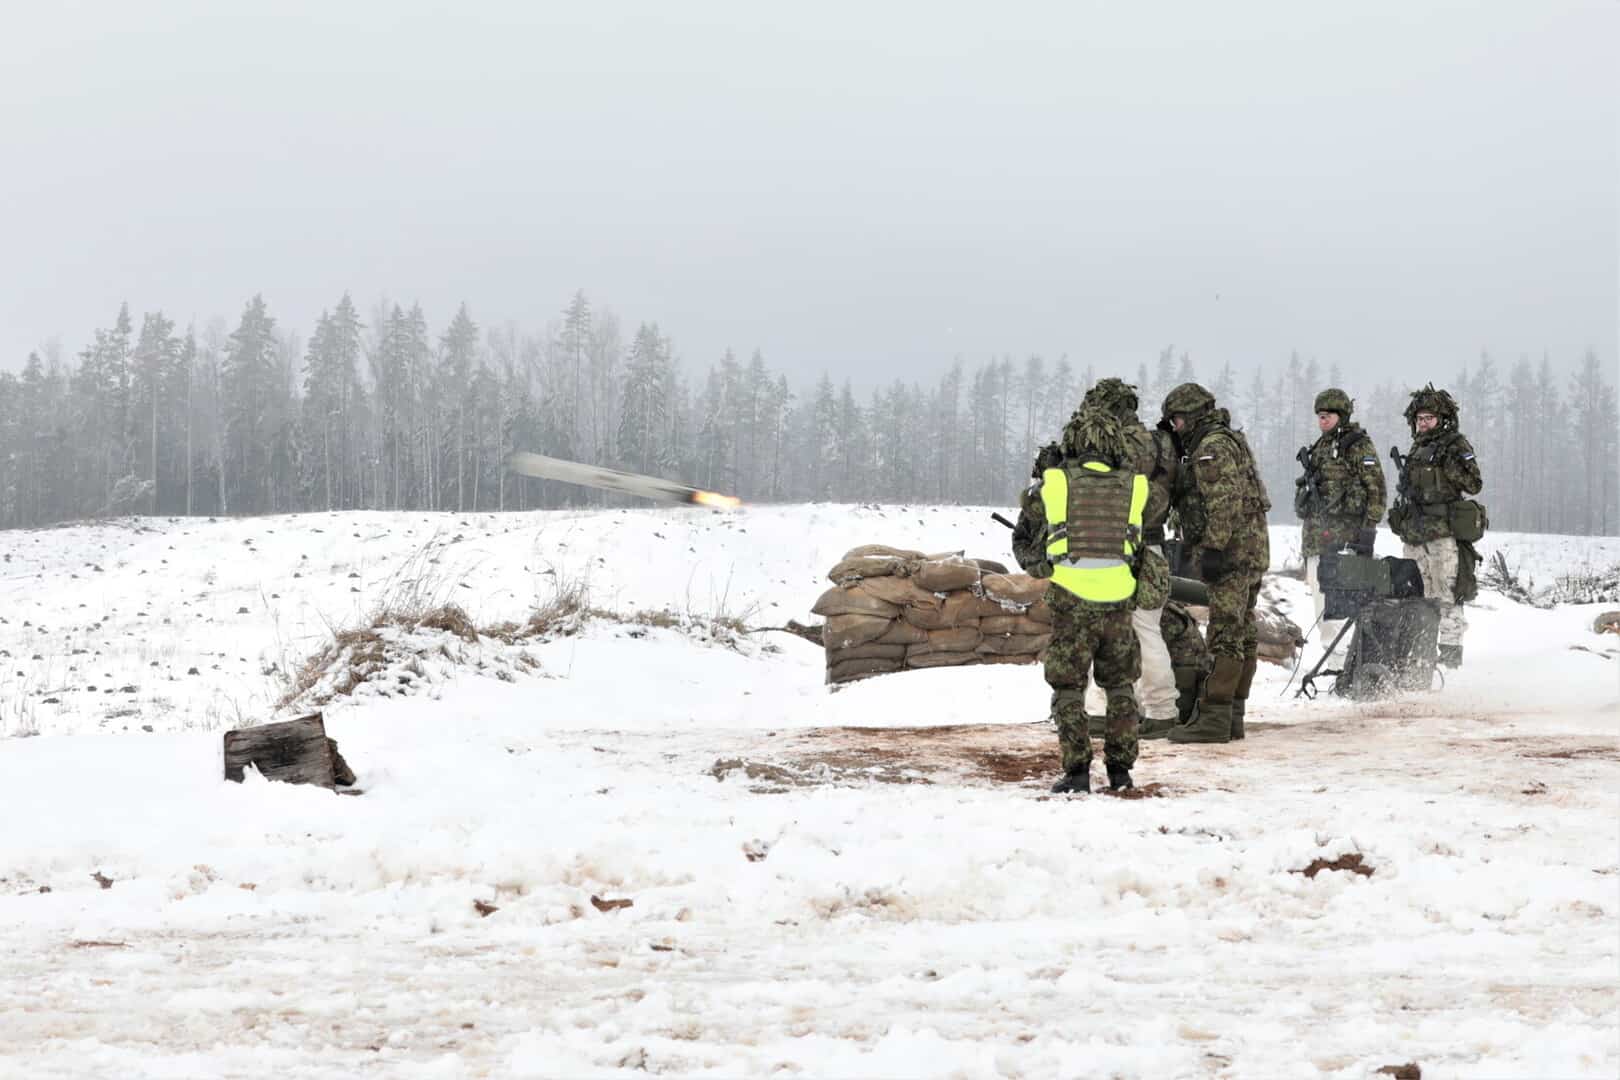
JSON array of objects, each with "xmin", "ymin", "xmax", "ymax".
[{"xmin": 1162, "ymin": 382, "xmax": 1272, "ymax": 743}]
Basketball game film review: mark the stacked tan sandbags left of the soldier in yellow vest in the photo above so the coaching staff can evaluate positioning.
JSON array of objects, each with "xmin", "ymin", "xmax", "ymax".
[{"xmin": 812, "ymin": 544, "xmax": 1051, "ymax": 683}]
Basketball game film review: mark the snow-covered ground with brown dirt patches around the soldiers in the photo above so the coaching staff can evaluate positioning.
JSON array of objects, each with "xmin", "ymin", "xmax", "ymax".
[{"xmin": 0, "ymin": 505, "xmax": 1620, "ymax": 1077}]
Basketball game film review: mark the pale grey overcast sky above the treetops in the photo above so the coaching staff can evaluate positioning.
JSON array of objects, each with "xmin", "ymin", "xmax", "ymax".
[{"xmin": 0, "ymin": 0, "xmax": 1620, "ymax": 384}]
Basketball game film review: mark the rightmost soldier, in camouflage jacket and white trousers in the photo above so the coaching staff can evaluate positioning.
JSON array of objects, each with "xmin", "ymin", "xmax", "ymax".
[{"xmin": 1390, "ymin": 382, "xmax": 1487, "ymax": 667}]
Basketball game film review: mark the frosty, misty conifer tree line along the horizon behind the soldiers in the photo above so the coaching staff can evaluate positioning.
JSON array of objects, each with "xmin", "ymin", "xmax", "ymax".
[{"xmin": 0, "ymin": 293, "xmax": 1620, "ymax": 534}]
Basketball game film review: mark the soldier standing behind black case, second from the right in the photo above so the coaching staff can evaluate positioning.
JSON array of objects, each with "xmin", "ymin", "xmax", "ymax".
[{"xmin": 1294, "ymin": 387, "xmax": 1387, "ymax": 665}]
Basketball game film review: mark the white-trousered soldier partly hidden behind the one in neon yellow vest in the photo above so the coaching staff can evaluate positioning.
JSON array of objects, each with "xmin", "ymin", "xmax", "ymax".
[{"xmin": 1082, "ymin": 379, "xmax": 1178, "ymax": 738}]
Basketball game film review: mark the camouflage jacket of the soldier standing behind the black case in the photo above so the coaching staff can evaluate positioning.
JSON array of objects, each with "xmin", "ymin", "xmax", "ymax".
[{"xmin": 1294, "ymin": 423, "xmax": 1388, "ymax": 555}]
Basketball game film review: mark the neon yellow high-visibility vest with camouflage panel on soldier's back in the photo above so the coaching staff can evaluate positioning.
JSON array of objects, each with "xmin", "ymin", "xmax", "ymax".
[{"xmin": 1040, "ymin": 460, "xmax": 1147, "ymax": 604}]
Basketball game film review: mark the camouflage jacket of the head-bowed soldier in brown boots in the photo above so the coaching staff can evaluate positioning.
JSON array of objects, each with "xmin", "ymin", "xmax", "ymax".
[{"xmin": 1175, "ymin": 408, "xmax": 1272, "ymax": 570}]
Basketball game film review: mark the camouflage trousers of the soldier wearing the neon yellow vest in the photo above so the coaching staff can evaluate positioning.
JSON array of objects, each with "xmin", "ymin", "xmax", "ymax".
[{"xmin": 1047, "ymin": 589, "xmax": 1142, "ymax": 772}]
